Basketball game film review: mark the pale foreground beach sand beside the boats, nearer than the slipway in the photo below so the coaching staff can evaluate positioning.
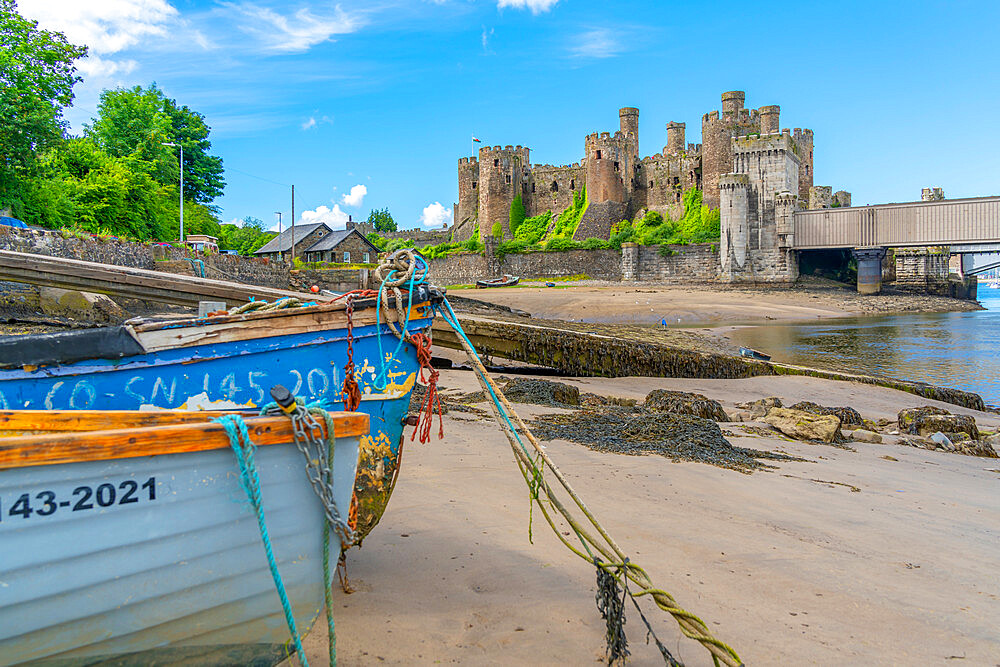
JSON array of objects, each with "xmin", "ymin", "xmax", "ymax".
[{"xmin": 294, "ymin": 371, "xmax": 1000, "ymax": 665}]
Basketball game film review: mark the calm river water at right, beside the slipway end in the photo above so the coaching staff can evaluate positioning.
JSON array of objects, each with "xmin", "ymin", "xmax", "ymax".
[{"xmin": 733, "ymin": 283, "xmax": 1000, "ymax": 405}]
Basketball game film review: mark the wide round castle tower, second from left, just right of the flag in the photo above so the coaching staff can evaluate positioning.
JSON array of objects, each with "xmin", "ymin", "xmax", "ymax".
[{"xmin": 478, "ymin": 146, "xmax": 531, "ymax": 238}]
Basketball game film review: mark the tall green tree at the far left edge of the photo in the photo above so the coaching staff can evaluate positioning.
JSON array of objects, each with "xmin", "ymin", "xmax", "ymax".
[{"xmin": 0, "ymin": 0, "xmax": 87, "ymax": 205}]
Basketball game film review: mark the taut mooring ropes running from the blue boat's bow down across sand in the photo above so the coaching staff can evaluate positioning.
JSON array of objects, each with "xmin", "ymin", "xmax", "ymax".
[{"xmin": 435, "ymin": 299, "xmax": 743, "ymax": 667}]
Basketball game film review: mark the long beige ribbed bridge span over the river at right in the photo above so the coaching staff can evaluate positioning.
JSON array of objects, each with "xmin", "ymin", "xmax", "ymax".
[{"xmin": 792, "ymin": 197, "xmax": 1000, "ymax": 250}]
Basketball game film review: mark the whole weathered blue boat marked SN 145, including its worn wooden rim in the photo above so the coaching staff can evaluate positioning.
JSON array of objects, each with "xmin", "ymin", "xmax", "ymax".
[{"xmin": 0, "ymin": 285, "xmax": 440, "ymax": 542}]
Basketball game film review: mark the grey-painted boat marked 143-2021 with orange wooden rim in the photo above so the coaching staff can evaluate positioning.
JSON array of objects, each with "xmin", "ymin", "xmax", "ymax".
[{"xmin": 0, "ymin": 410, "xmax": 368, "ymax": 667}]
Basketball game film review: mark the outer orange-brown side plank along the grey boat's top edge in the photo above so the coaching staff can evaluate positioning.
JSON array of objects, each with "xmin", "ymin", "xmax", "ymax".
[{"xmin": 0, "ymin": 412, "xmax": 370, "ymax": 470}]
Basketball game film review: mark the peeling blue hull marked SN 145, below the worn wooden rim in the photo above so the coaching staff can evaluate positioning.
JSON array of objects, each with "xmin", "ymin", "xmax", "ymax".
[{"xmin": 0, "ymin": 318, "xmax": 431, "ymax": 543}]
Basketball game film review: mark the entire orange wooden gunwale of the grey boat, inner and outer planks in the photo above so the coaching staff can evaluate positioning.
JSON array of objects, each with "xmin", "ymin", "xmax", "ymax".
[{"xmin": 0, "ymin": 410, "xmax": 370, "ymax": 470}]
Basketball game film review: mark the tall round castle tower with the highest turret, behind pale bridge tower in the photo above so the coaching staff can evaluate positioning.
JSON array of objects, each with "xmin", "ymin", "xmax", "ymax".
[{"xmin": 701, "ymin": 90, "xmax": 760, "ymax": 208}]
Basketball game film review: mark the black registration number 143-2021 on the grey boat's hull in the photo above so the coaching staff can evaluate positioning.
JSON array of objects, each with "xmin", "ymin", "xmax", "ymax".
[{"xmin": 0, "ymin": 477, "xmax": 156, "ymax": 522}]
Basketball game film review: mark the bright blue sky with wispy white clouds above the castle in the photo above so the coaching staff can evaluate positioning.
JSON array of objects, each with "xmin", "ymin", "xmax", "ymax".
[{"xmin": 19, "ymin": 0, "xmax": 1000, "ymax": 228}]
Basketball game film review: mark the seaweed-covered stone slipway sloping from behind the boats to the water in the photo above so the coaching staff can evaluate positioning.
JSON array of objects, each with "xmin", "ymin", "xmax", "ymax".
[{"xmin": 434, "ymin": 315, "xmax": 985, "ymax": 410}]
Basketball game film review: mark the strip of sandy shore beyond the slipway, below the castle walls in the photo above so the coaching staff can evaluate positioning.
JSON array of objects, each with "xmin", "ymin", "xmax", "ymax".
[{"xmin": 454, "ymin": 281, "xmax": 979, "ymax": 326}]
